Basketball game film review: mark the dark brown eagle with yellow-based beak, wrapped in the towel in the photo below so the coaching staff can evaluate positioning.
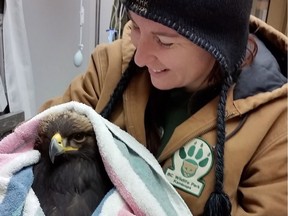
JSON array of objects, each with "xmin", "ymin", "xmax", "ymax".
[{"xmin": 32, "ymin": 110, "xmax": 112, "ymax": 216}]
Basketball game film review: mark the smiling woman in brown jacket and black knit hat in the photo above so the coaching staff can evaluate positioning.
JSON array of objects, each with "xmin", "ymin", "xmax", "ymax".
[{"xmin": 41, "ymin": 0, "xmax": 288, "ymax": 215}]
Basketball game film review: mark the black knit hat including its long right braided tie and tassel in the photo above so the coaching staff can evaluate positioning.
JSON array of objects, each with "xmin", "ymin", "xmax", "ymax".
[{"xmin": 116, "ymin": 0, "xmax": 252, "ymax": 216}]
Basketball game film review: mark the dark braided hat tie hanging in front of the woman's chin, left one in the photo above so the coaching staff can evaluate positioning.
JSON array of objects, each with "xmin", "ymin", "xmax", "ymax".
[{"xmin": 100, "ymin": 57, "xmax": 138, "ymax": 119}]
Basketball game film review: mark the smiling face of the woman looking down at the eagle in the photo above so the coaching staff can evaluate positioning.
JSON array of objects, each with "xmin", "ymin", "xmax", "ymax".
[{"xmin": 129, "ymin": 12, "xmax": 215, "ymax": 91}]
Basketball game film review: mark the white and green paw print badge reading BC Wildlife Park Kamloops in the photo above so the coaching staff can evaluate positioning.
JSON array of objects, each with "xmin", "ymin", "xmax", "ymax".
[{"xmin": 165, "ymin": 138, "xmax": 213, "ymax": 196}]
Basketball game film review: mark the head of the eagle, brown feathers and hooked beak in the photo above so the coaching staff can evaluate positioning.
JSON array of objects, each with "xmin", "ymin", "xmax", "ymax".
[{"xmin": 35, "ymin": 110, "xmax": 100, "ymax": 163}]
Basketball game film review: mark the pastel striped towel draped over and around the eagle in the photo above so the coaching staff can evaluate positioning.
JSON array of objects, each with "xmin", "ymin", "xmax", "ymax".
[{"xmin": 0, "ymin": 102, "xmax": 192, "ymax": 216}]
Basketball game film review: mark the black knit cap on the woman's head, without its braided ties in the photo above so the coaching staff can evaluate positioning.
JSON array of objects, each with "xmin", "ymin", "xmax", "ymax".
[{"xmin": 121, "ymin": 0, "xmax": 252, "ymax": 77}]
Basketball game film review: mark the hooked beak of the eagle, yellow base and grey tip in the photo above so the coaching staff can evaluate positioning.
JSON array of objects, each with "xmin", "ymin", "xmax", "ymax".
[{"xmin": 49, "ymin": 133, "xmax": 78, "ymax": 163}]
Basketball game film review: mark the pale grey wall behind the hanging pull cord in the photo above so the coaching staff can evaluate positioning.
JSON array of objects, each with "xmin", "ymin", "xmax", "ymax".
[{"xmin": 23, "ymin": 0, "xmax": 113, "ymax": 111}]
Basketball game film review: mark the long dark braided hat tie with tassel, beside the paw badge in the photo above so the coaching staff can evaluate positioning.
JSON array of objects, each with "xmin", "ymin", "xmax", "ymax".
[{"xmin": 204, "ymin": 75, "xmax": 232, "ymax": 216}]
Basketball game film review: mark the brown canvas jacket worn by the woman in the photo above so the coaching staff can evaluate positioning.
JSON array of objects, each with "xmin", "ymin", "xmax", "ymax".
[{"xmin": 40, "ymin": 17, "xmax": 288, "ymax": 216}]
